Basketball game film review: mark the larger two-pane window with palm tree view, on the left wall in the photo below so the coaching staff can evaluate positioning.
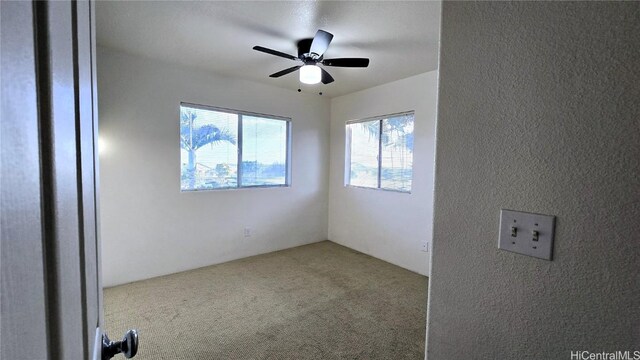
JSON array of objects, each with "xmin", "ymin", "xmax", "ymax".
[{"xmin": 180, "ymin": 103, "xmax": 291, "ymax": 191}]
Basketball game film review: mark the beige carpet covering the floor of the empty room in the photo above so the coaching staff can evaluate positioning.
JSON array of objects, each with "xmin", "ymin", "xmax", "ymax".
[{"xmin": 104, "ymin": 241, "xmax": 427, "ymax": 360}]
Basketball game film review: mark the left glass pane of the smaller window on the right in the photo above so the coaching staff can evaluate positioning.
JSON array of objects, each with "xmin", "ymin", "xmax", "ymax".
[{"xmin": 347, "ymin": 120, "xmax": 380, "ymax": 188}]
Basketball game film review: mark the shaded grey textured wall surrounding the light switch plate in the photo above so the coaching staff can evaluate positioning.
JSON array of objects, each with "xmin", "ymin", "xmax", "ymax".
[{"xmin": 427, "ymin": 2, "xmax": 640, "ymax": 360}]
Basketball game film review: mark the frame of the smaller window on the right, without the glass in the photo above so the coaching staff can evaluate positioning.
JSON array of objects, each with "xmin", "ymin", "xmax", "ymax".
[{"xmin": 344, "ymin": 110, "xmax": 416, "ymax": 194}]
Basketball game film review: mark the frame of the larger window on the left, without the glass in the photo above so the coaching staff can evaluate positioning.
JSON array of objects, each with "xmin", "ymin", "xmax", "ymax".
[{"xmin": 178, "ymin": 101, "xmax": 291, "ymax": 192}]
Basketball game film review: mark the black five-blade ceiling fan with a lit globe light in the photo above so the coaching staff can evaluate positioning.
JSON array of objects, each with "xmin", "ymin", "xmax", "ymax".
[{"xmin": 253, "ymin": 30, "xmax": 369, "ymax": 84}]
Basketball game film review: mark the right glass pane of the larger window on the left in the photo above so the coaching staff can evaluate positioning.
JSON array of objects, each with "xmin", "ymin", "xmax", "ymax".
[{"xmin": 241, "ymin": 115, "xmax": 287, "ymax": 186}]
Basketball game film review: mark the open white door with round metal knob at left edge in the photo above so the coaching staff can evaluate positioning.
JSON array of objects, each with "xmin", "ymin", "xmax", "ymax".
[{"xmin": 0, "ymin": 1, "xmax": 137, "ymax": 360}]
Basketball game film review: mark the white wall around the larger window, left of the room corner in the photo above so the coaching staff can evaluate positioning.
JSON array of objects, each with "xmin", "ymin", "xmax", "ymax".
[{"xmin": 97, "ymin": 48, "xmax": 329, "ymax": 286}]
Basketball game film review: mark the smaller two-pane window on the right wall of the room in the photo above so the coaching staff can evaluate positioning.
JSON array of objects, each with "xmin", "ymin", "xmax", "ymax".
[{"xmin": 345, "ymin": 112, "xmax": 413, "ymax": 192}]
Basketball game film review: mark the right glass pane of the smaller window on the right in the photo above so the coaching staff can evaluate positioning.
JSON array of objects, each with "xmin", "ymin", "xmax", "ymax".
[{"xmin": 380, "ymin": 114, "xmax": 413, "ymax": 191}]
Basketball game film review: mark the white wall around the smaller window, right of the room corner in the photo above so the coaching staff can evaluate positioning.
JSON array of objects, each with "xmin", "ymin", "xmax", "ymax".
[{"xmin": 329, "ymin": 71, "xmax": 437, "ymax": 275}]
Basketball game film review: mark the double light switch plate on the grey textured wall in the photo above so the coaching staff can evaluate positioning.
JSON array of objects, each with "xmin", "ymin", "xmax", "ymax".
[{"xmin": 498, "ymin": 209, "xmax": 556, "ymax": 260}]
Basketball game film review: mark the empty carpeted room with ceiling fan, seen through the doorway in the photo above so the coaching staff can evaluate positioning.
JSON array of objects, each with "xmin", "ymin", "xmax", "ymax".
[{"xmin": 96, "ymin": 2, "xmax": 440, "ymax": 359}]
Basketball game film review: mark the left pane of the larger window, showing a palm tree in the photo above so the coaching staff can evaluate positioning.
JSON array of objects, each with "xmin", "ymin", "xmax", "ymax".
[{"xmin": 180, "ymin": 106, "xmax": 238, "ymax": 190}]
